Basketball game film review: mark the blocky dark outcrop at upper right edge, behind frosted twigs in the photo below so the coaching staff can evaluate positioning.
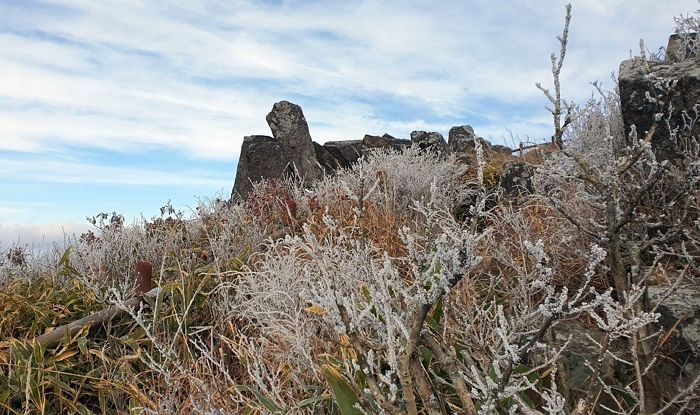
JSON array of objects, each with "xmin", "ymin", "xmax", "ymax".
[{"xmin": 619, "ymin": 54, "xmax": 700, "ymax": 160}]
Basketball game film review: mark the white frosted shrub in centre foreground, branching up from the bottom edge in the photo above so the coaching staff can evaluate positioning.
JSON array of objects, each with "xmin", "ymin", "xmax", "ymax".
[{"xmin": 221, "ymin": 182, "xmax": 480, "ymax": 408}]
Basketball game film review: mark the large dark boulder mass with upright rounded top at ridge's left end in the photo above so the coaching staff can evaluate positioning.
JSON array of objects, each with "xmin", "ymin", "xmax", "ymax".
[{"xmin": 231, "ymin": 101, "xmax": 326, "ymax": 198}]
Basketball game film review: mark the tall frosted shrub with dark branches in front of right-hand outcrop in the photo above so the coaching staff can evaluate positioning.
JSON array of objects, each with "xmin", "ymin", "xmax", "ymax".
[{"xmin": 534, "ymin": 12, "xmax": 699, "ymax": 413}]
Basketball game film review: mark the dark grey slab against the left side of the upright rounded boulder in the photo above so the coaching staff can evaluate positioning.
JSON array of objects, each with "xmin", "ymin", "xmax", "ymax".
[{"xmin": 231, "ymin": 135, "xmax": 290, "ymax": 199}]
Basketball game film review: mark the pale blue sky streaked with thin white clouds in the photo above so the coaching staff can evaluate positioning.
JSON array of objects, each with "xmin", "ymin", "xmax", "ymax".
[{"xmin": 0, "ymin": 0, "xmax": 700, "ymax": 247}]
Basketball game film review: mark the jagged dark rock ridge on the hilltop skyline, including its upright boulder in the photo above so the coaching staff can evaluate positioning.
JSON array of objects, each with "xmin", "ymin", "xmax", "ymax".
[{"xmin": 231, "ymin": 101, "xmax": 512, "ymax": 199}]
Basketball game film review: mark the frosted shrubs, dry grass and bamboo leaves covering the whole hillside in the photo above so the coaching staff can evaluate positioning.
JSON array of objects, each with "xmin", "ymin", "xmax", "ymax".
[{"xmin": 0, "ymin": 4, "xmax": 700, "ymax": 415}]
